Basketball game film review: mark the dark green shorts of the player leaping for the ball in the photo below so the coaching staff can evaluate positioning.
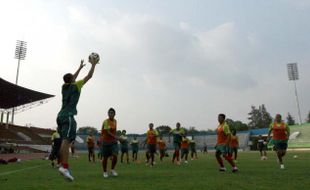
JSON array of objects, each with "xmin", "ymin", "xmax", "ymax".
[{"xmin": 56, "ymin": 116, "xmax": 76, "ymax": 142}]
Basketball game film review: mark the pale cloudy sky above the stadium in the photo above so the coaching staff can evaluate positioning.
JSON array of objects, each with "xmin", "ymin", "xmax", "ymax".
[{"xmin": 0, "ymin": 0, "xmax": 310, "ymax": 133}]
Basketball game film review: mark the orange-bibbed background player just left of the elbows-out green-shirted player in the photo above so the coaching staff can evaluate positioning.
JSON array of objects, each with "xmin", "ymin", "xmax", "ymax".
[{"xmin": 145, "ymin": 123, "xmax": 158, "ymax": 166}]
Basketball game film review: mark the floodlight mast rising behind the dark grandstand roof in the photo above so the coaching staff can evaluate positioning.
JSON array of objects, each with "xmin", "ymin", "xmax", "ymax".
[{"xmin": 12, "ymin": 40, "xmax": 27, "ymax": 124}]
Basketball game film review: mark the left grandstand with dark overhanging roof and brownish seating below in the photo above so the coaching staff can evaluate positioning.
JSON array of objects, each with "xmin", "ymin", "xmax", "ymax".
[{"xmin": 0, "ymin": 78, "xmax": 54, "ymax": 152}]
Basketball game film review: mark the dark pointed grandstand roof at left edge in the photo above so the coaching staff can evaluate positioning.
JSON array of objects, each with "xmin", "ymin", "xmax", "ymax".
[{"xmin": 0, "ymin": 78, "xmax": 54, "ymax": 109}]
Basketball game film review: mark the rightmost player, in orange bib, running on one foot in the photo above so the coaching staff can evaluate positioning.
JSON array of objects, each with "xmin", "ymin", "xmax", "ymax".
[{"xmin": 268, "ymin": 114, "xmax": 290, "ymax": 169}]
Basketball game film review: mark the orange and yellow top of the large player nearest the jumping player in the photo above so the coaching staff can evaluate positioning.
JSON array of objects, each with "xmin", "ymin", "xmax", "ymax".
[{"xmin": 101, "ymin": 119, "xmax": 117, "ymax": 142}]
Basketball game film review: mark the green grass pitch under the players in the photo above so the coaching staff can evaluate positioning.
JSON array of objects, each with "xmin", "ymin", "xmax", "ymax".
[{"xmin": 0, "ymin": 151, "xmax": 310, "ymax": 190}]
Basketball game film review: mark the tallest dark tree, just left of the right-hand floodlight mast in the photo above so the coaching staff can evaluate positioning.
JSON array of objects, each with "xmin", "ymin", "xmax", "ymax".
[{"xmin": 248, "ymin": 104, "xmax": 272, "ymax": 129}]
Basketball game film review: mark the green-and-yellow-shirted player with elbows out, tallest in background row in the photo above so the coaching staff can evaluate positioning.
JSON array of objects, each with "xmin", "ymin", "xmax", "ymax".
[{"xmin": 169, "ymin": 122, "xmax": 185, "ymax": 165}]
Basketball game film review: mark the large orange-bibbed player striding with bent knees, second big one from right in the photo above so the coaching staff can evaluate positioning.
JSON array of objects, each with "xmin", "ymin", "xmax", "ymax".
[{"xmin": 215, "ymin": 113, "xmax": 238, "ymax": 172}]
